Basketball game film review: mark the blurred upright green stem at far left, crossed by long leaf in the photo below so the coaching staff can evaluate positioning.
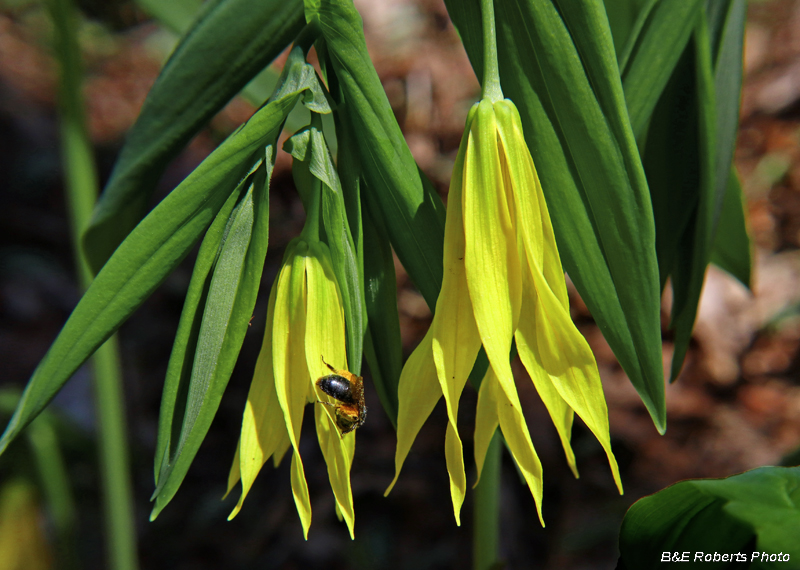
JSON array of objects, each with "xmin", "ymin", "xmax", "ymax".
[{"xmin": 47, "ymin": 0, "xmax": 139, "ymax": 570}]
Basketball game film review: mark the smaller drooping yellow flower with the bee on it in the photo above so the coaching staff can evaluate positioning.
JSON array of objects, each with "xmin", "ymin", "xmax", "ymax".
[{"xmin": 228, "ymin": 236, "xmax": 356, "ymax": 538}]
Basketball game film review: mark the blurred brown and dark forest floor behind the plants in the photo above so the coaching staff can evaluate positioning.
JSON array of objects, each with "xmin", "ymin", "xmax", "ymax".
[{"xmin": 0, "ymin": 0, "xmax": 800, "ymax": 570}]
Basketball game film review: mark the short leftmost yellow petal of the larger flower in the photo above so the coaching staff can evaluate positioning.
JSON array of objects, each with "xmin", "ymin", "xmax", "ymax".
[{"xmin": 384, "ymin": 329, "xmax": 442, "ymax": 496}]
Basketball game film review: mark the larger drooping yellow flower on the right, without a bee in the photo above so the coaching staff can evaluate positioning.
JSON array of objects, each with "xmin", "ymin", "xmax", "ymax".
[{"xmin": 386, "ymin": 99, "xmax": 622, "ymax": 525}]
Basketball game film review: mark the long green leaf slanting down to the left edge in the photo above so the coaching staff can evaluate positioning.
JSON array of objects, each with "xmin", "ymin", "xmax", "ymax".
[{"xmin": 0, "ymin": 49, "xmax": 328, "ymax": 453}]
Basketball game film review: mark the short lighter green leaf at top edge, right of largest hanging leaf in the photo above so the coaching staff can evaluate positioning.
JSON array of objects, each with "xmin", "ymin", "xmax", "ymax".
[{"xmin": 620, "ymin": 0, "xmax": 703, "ymax": 140}]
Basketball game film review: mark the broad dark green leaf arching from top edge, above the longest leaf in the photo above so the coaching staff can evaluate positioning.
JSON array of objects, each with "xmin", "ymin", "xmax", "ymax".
[{"xmin": 84, "ymin": 0, "xmax": 303, "ymax": 271}]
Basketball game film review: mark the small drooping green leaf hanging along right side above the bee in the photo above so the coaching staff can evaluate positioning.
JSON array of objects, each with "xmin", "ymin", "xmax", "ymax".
[{"xmin": 285, "ymin": 115, "xmax": 366, "ymax": 375}]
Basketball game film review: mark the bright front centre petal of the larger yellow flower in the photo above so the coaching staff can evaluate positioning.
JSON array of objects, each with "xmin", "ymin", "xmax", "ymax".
[{"xmin": 463, "ymin": 100, "xmax": 522, "ymax": 418}]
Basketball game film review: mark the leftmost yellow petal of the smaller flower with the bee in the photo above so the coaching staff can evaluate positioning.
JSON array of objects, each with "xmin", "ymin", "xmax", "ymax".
[{"xmin": 228, "ymin": 284, "xmax": 287, "ymax": 520}]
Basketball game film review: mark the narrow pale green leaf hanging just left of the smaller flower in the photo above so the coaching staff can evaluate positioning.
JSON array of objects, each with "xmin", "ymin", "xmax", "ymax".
[{"xmin": 150, "ymin": 149, "xmax": 277, "ymax": 520}]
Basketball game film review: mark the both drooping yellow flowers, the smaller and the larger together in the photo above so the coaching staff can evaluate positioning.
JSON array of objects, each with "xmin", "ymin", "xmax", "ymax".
[{"xmin": 222, "ymin": 99, "xmax": 622, "ymax": 536}]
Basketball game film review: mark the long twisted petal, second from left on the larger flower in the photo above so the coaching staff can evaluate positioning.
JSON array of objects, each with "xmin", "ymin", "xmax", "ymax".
[{"xmin": 431, "ymin": 107, "xmax": 481, "ymax": 524}]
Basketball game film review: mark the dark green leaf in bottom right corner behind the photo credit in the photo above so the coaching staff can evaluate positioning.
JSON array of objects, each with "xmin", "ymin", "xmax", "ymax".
[{"xmin": 617, "ymin": 467, "xmax": 800, "ymax": 570}]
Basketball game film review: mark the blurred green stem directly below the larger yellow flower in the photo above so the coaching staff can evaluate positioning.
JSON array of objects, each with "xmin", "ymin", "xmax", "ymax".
[{"xmin": 472, "ymin": 431, "xmax": 503, "ymax": 570}]
